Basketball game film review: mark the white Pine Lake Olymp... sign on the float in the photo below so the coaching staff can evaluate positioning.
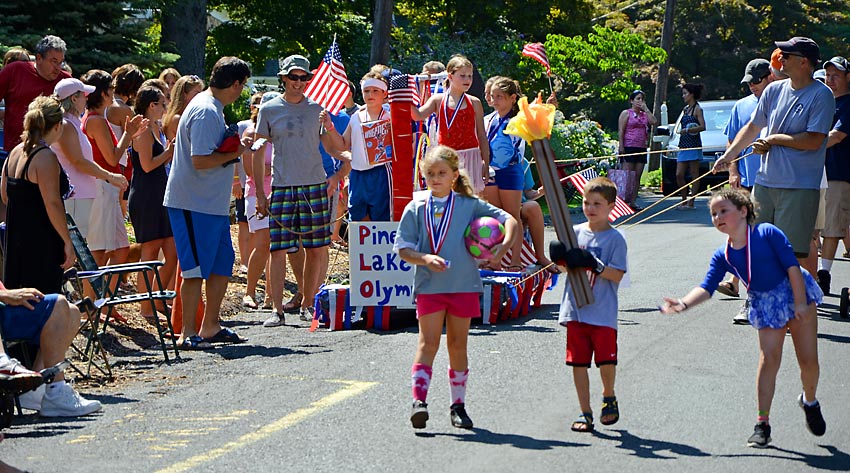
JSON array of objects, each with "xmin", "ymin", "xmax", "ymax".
[{"xmin": 349, "ymin": 222, "xmax": 414, "ymax": 308}]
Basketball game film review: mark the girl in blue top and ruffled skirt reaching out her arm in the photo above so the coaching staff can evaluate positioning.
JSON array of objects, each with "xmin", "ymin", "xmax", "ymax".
[{"xmin": 661, "ymin": 189, "xmax": 826, "ymax": 448}]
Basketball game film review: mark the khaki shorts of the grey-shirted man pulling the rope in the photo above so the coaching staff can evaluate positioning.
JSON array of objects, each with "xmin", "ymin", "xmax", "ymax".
[{"xmin": 753, "ymin": 184, "xmax": 820, "ymax": 258}]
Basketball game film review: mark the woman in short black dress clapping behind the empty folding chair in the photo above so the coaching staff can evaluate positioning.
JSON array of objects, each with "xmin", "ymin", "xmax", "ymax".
[{"xmin": 129, "ymin": 86, "xmax": 177, "ymax": 320}]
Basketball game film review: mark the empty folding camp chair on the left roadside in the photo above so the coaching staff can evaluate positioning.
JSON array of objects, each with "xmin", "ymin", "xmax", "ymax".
[{"xmin": 66, "ymin": 214, "xmax": 180, "ymax": 377}]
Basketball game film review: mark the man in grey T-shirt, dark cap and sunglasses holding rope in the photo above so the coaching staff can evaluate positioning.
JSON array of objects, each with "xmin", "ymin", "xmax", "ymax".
[{"xmin": 715, "ymin": 37, "xmax": 835, "ymax": 274}]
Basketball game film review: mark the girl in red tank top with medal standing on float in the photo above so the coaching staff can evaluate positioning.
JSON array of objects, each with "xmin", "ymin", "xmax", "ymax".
[{"xmin": 411, "ymin": 56, "xmax": 490, "ymax": 194}]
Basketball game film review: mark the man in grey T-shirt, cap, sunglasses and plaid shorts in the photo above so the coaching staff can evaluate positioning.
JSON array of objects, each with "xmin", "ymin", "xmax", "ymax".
[{"xmin": 254, "ymin": 55, "xmax": 342, "ymax": 327}]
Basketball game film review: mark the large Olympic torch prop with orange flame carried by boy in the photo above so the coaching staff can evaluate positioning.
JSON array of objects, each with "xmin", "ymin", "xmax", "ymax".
[{"xmin": 505, "ymin": 94, "xmax": 593, "ymax": 307}]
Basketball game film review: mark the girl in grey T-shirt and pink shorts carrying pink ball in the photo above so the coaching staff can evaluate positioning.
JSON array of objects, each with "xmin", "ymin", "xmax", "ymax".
[{"xmin": 394, "ymin": 146, "xmax": 519, "ymax": 429}]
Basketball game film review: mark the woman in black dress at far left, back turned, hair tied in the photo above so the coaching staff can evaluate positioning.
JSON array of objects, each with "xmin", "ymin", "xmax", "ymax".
[{"xmin": 0, "ymin": 97, "xmax": 76, "ymax": 294}]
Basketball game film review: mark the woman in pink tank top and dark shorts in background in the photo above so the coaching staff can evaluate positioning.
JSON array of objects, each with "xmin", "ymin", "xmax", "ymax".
[{"xmin": 619, "ymin": 90, "xmax": 658, "ymax": 207}]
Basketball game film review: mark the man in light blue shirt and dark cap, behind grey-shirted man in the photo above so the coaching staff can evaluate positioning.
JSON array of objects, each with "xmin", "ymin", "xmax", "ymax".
[{"xmin": 717, "ymin": 58, "xmax": 774, "ymax": 325}]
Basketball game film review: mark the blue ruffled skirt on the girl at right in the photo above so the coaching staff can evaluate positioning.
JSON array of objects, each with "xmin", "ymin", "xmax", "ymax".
[{"xmin": 747, "ymin": 268, "xmax": 823, "ymax": 329}]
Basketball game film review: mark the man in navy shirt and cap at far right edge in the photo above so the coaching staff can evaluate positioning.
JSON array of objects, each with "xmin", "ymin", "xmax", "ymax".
[{"xmin": 818, "ymin": 56, "xmax": 850, "ymax": 293}]
